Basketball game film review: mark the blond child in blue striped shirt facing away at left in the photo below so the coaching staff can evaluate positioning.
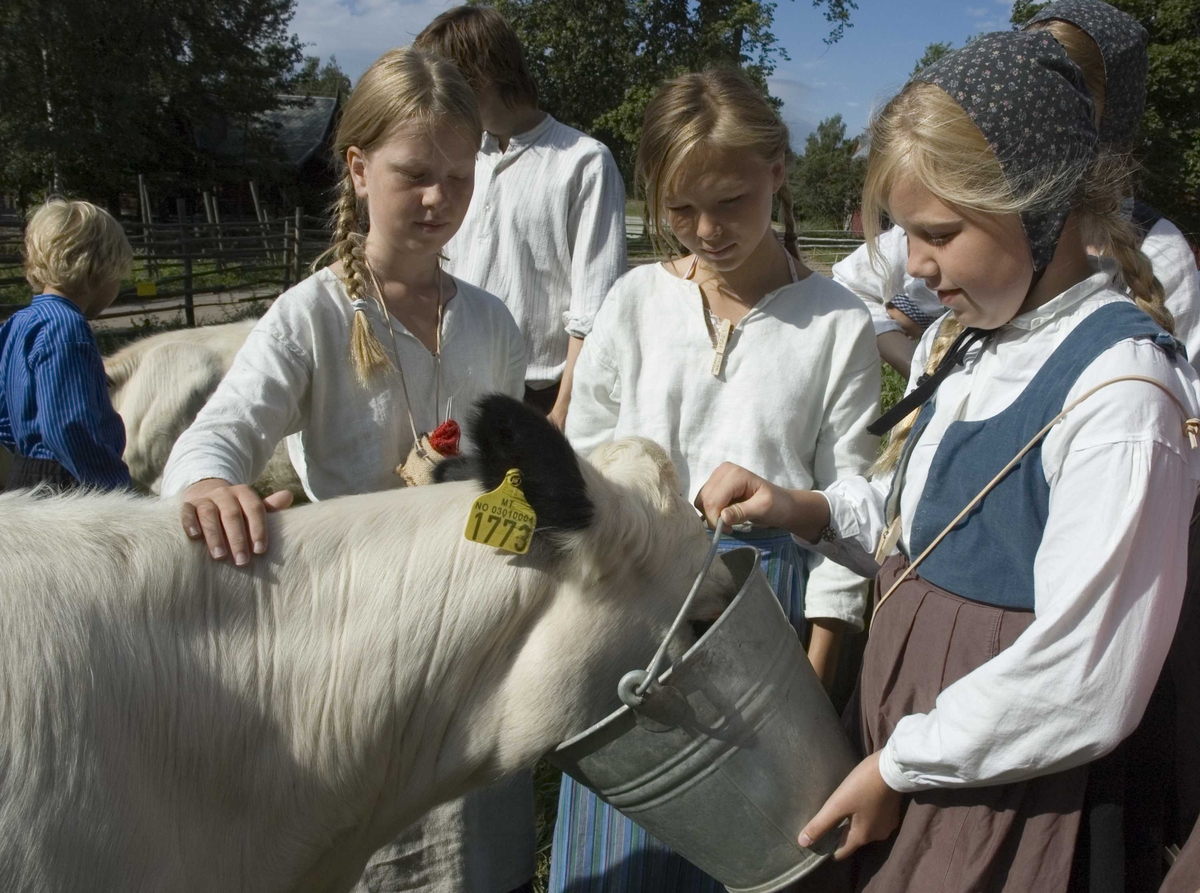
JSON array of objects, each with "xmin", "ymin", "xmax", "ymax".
[{"xmin": 0, "ymin": 198, "xmax": 133, "ymax": 490}]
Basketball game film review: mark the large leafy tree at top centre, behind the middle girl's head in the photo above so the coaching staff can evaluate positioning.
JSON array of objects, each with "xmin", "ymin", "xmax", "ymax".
[{"xmin": 470, "ymin": 0, "xmax": 857, "ymax": 180}]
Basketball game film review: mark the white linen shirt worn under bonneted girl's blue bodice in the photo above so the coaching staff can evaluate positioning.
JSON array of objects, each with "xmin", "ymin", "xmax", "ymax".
[{"xmin": 826, "ymin": 259, "xmax": 1200, "ymax": 791}]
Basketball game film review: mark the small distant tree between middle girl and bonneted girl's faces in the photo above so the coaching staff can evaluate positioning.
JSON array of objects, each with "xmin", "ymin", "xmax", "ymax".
[{"xmin": 792, "ymin": 115, "xmax": 866, "ymax": 229}]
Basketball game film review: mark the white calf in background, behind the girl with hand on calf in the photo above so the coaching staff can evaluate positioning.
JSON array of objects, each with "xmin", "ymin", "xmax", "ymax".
[{"xmin": 104, "ymin": 319, "xmax": 304, "ymax": 497}]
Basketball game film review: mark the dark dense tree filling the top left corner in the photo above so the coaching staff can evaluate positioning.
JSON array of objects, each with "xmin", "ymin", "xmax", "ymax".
[{"xmin": 0, "ymin": 0, "xmax": 301, "ymax": 204}]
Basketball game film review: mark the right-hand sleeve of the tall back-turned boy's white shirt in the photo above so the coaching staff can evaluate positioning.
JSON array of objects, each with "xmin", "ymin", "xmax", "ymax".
[{"xmin": 563, "ymin": 149, "xmax": 628, "ymax": 338}]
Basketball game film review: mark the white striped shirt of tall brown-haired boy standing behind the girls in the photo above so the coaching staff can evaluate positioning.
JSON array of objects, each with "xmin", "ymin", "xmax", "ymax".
[{"xmin": 445, "ymin": 115, "xmax": 626, "ymax": 388}]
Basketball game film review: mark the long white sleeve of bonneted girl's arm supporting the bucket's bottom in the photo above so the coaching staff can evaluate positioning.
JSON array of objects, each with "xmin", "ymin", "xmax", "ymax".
[{"xmin": 880, "ymin": 344, "xmax": 1196, "ymax": 791}]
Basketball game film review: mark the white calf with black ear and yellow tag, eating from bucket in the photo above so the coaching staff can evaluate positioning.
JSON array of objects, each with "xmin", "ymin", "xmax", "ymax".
[{"xmin": 0, "ymin": 397, "xmax": 732, "ymax": 893}]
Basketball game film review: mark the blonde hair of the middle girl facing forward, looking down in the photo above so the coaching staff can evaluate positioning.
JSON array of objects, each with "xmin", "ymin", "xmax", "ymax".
[{"xmin": 635, "ymin": 68, "xmax": 799, "ymax": 259}]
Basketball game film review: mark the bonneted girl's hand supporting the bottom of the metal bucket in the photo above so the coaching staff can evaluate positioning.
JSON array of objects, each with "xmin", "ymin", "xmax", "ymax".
[{"xmin": 799, "ymin": 751, "xmax": 901, "ymax": 859}]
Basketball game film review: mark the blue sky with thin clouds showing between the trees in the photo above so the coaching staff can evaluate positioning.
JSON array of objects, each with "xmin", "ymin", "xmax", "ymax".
[{"xmin": 293, "ymin": 0, "xmax": 1013, "ymax": 150}]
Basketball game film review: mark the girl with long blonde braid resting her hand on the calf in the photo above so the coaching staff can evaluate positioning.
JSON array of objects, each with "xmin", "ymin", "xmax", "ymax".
[{"xmin": 162, "ymin": 48, "xmax": 534, "ymax": 893}]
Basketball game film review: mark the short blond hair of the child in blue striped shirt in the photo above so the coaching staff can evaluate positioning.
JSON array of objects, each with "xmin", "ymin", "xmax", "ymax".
[{"xmin": 24, "ymin": 198, "xmax": 133, "ymax": 300}]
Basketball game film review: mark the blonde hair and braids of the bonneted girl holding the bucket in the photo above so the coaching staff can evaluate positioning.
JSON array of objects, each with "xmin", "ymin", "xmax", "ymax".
[{"xmin": 863, "ymin": 82, "xmax": 1174, "ymax": 471}]
